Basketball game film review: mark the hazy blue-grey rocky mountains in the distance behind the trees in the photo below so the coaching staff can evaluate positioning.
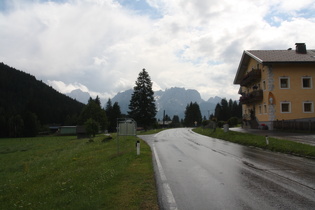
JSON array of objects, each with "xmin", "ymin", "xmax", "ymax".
[{"xmin": 67, "ymin": 87, "xmax": 222, "ymax": 120}]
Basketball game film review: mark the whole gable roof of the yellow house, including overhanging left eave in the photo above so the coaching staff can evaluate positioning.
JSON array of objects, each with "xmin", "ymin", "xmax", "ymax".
[{"xmin": 234, "ymin": 50, "xmax": 315, "ymax": 84}]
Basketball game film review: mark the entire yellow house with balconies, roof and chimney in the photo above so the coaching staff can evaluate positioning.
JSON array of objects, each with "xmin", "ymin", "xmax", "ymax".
[{"xmin": 234, "ymin": 43, "xmax": 315, "ymax": 129}]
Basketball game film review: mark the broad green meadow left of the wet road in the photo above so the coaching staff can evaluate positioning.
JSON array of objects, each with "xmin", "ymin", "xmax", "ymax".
[{"xmin": 0, "ymin": 136, "xmax": 158, "ymax": 209}]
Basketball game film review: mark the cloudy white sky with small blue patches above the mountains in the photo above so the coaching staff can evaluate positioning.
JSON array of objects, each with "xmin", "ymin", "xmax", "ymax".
[{"xmin": 0, "ymin": 0, "xmax": 315, "ymax": 100}]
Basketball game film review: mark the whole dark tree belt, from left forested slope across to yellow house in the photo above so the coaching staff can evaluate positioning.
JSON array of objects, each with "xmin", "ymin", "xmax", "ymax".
[{"xmin": 0, "ymin": 63, "xmax": 241, "ymax": 137}]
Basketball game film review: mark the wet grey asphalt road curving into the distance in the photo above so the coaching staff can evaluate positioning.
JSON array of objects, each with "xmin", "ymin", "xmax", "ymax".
[{"xmin": 139, "ymin": 128, "xmax": 315, "ymax": 210}]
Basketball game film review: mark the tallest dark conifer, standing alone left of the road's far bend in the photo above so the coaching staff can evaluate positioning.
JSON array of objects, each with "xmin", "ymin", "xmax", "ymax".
[{"xmin": 128, "ymin": 69, "xmax": 157, "ymax": 129}]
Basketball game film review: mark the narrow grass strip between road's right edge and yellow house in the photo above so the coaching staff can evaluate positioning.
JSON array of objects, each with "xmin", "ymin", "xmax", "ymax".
[{"xmin": 193, "ymin": 128, "xmax": 315, "ymax": 158}]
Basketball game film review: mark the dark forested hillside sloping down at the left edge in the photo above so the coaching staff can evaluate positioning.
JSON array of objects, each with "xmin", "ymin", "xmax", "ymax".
[{"xmin": 0, "ymin": 63, "xmax": 84, "ymax": 137}]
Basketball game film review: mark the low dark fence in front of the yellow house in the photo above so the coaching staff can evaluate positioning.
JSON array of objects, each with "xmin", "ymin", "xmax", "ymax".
[{"xmin": 273, "ymin": 120, "xmax": 315, "ymax": 131}]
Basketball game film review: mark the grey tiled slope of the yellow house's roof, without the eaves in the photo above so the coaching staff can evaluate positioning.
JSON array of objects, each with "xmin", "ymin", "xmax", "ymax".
[{"xmin": 245, "ymin": 50, "xmax": 315, "ymax": 63}]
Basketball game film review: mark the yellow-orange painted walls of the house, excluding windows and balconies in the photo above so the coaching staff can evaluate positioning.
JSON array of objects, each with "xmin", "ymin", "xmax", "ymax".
[{"xmin": 242, "ymin": 59, "xmax": 315, "ymax": 122}]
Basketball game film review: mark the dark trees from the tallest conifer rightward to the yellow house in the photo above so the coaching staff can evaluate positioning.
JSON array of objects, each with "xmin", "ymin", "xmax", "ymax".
[{"xmin": 128, "ymin": 69, "xmax": 242, "ymax": 129}]
